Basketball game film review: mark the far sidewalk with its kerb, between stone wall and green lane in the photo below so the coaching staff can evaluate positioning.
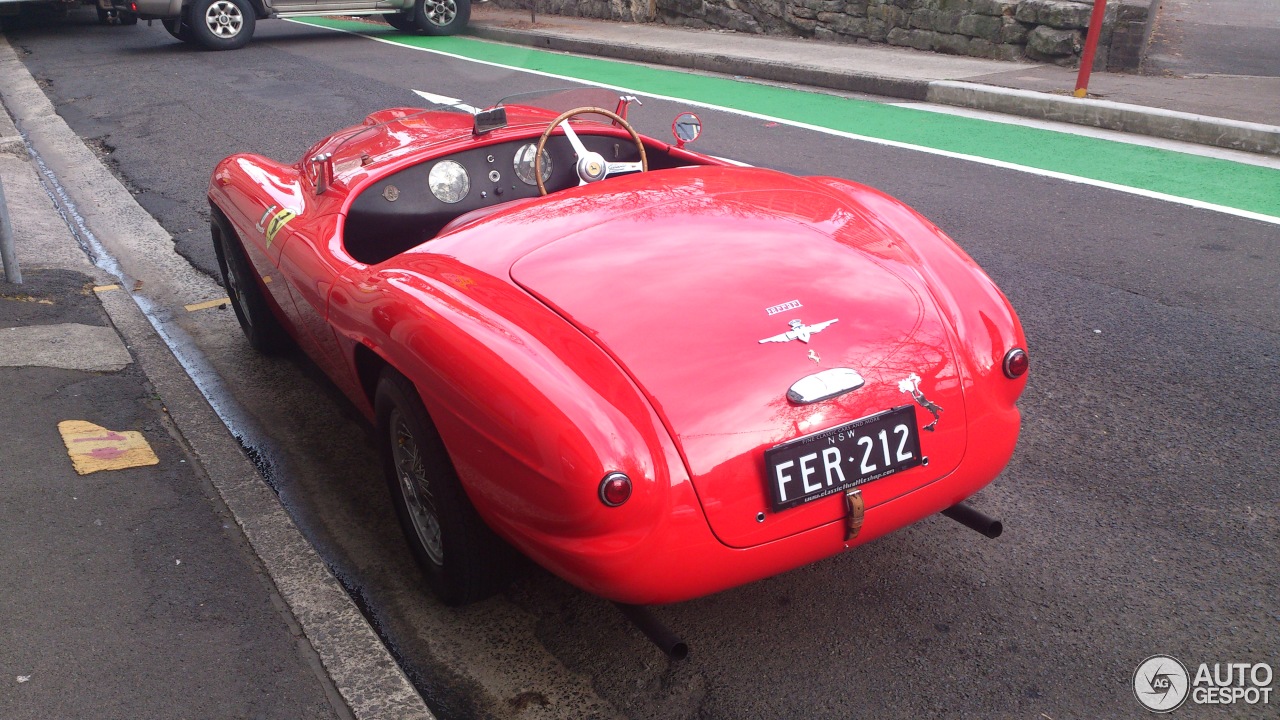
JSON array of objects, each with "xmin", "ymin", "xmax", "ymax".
[{"xmin": 468, "ymin": 4, "xmax": 1280, "ymax": 155}]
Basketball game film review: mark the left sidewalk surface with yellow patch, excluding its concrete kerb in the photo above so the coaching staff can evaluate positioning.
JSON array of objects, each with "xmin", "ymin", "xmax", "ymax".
[{"xmin": 0, "ymin": 83, "xmax": 351, "ymax": 720}]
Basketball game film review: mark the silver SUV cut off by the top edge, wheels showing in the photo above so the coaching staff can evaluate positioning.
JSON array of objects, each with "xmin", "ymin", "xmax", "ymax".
[{"xmin": 113, "ymin": 0, "xmax": 471, "ymax": 50}]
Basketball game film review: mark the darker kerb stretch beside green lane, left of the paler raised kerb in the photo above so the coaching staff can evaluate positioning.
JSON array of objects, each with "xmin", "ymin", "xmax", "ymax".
[{"xmin": 467, "ymin": 23, "xmax": 929, "ymax": 101}]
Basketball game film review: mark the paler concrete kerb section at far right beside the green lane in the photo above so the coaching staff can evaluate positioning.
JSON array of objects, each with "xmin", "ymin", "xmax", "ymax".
[{"xmin": 925, "ymin": 79, "xmax": 1280, "ymax": 155}]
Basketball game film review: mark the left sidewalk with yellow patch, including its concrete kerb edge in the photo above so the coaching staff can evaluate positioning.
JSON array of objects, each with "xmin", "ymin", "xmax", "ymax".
[{"xmin": 0, "ymin": 63, "xmax": 430, "ymax": 720}]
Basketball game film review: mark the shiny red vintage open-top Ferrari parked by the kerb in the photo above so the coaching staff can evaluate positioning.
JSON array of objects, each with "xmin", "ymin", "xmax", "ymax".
[{"xmin": 209, "ymin": 90, "xmax": 1028, "ymax": 617}]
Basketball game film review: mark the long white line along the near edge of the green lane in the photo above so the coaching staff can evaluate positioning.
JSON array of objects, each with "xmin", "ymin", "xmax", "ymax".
[{"xmin": 291, "ymin": 20, "xmax": 1280, "ymax": 225}]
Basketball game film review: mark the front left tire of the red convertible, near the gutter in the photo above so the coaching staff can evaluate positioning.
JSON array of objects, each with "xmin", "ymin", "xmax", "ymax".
[{"xmin": 209, "ymin": 211, "xmax": 292, "ymax": 355}]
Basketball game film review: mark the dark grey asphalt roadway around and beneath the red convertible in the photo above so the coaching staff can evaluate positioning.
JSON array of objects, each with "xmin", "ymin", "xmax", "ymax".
[{"xmin": 10, "ymin": 14, "xmax": 1280, "ymax": 720}]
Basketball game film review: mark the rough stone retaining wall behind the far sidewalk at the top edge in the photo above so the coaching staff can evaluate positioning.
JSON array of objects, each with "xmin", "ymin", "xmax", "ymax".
[{"xmin": 493, "ymin": 0, "xmax": 1155, "ymax": 70}]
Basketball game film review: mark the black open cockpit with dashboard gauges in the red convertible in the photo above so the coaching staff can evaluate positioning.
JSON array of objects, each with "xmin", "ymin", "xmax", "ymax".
[{"xmin": 343, "ymin": 131, "xmax": 687, "ymax": 265}]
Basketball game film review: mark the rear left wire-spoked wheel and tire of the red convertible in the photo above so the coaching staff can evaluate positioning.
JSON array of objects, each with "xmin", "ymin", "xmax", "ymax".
[{"xmin": 374, "ymin": 368, "xmax": 516, "ymax": 606}]
